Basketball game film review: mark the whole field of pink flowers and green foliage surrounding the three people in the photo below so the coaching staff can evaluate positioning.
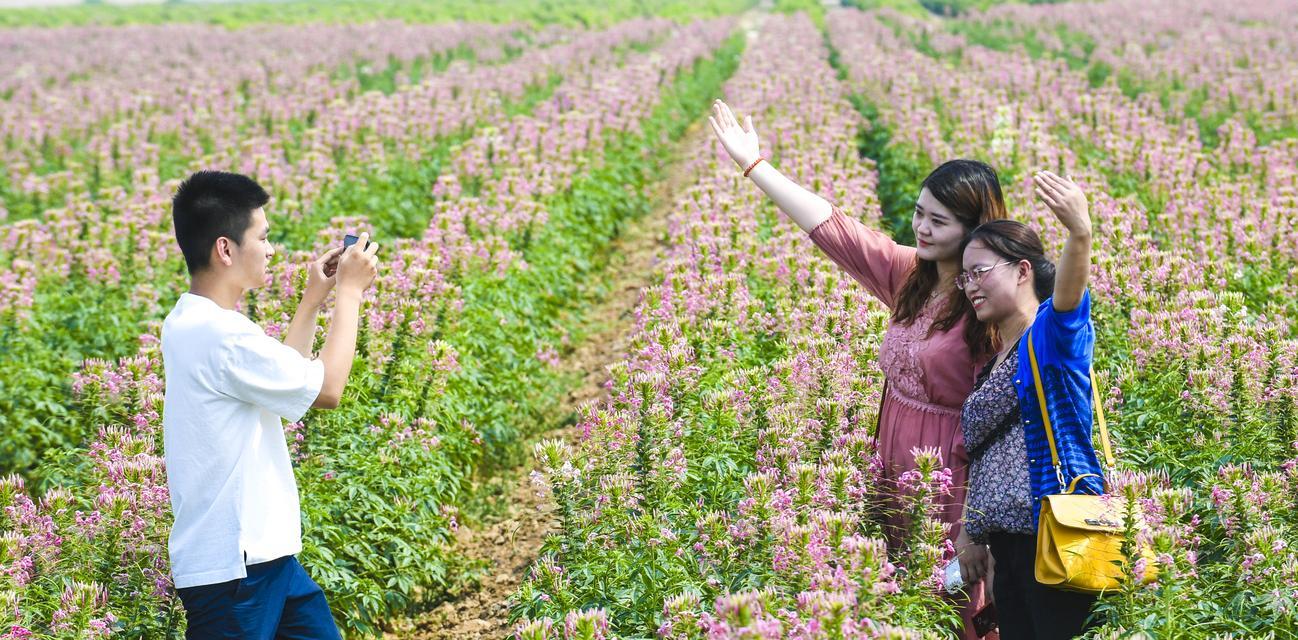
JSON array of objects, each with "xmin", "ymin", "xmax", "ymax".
[{"xmin": 0, "ymin": 0, "xmax": 1298, "ymax": 640}]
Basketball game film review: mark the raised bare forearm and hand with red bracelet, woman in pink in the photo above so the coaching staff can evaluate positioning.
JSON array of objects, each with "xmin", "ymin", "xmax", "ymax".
[{"xmin": 707, "ymin": 100, "xmax": 833, "ymax": 232}]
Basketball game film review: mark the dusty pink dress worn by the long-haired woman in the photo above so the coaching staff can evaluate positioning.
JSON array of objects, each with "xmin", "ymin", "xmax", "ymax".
[{"xmin": 810, "ymin": 208, "xmax": 998, "ymax": 639}]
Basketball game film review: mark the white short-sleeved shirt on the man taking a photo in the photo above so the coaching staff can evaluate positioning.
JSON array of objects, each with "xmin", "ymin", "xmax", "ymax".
[{"xmin": 162, "ymin": 293, "xmax": 325, "ymax": 588}]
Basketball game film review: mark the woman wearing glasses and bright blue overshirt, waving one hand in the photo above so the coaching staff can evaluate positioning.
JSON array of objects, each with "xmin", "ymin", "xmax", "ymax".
[{"xmin": 955, "ymin": 171, "xmax": 1103, "ymax": 640}]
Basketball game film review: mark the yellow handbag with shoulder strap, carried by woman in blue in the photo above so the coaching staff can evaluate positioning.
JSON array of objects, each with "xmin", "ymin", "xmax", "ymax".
[{"xmin": 1028, "ymin": 338, "xmax": 1158, "ymax": 593}]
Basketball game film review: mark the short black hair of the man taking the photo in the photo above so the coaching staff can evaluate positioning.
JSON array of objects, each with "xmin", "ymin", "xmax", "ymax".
[{"xmin": 171, "ymin": 171, "xmax": 270, "ymax": 275}]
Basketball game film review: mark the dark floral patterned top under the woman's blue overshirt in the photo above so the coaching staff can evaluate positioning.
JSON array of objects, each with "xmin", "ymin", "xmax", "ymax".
[{"xmin": 961, "ymin": 347, "xmax": 1036, "ymax": 544}]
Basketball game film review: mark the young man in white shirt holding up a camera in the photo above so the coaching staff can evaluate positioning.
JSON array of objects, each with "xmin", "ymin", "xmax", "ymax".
[{"xmin": 162, "ymin": 171, "xmax": 378, "ymax": 639}]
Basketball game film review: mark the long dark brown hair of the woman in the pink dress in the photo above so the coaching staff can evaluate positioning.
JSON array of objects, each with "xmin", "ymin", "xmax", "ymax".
[{"xmin": 892, "ymin": 160, "xmax": 1007, "ymax": 357}]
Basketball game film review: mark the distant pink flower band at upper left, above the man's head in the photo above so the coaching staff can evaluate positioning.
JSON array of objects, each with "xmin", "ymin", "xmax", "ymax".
[{"xmin": 0, "ymin": 22, "xmax": 547, "ymax": 214}]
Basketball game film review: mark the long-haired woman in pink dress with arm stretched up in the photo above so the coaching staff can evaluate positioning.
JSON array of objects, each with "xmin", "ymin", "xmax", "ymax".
[{"xmin": 709, "ymin": 100, "xmax": 1006, "ymax": 640}]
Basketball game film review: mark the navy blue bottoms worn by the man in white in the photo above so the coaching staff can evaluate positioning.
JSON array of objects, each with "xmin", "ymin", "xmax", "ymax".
[{"xmin": 177, "ymin": 556, "xmax": 341, "ymax": 640}]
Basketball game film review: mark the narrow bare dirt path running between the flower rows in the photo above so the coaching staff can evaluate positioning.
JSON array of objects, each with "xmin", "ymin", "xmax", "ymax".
[{"xmin": 384, "ymin": 122, "xmax": 707, "ymax": 640}]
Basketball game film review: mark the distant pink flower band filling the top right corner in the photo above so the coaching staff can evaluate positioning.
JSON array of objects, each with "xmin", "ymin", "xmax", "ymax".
[{"xmin": 971, "ymin": 0, "xmax": 1298, "ymax": 136}]
